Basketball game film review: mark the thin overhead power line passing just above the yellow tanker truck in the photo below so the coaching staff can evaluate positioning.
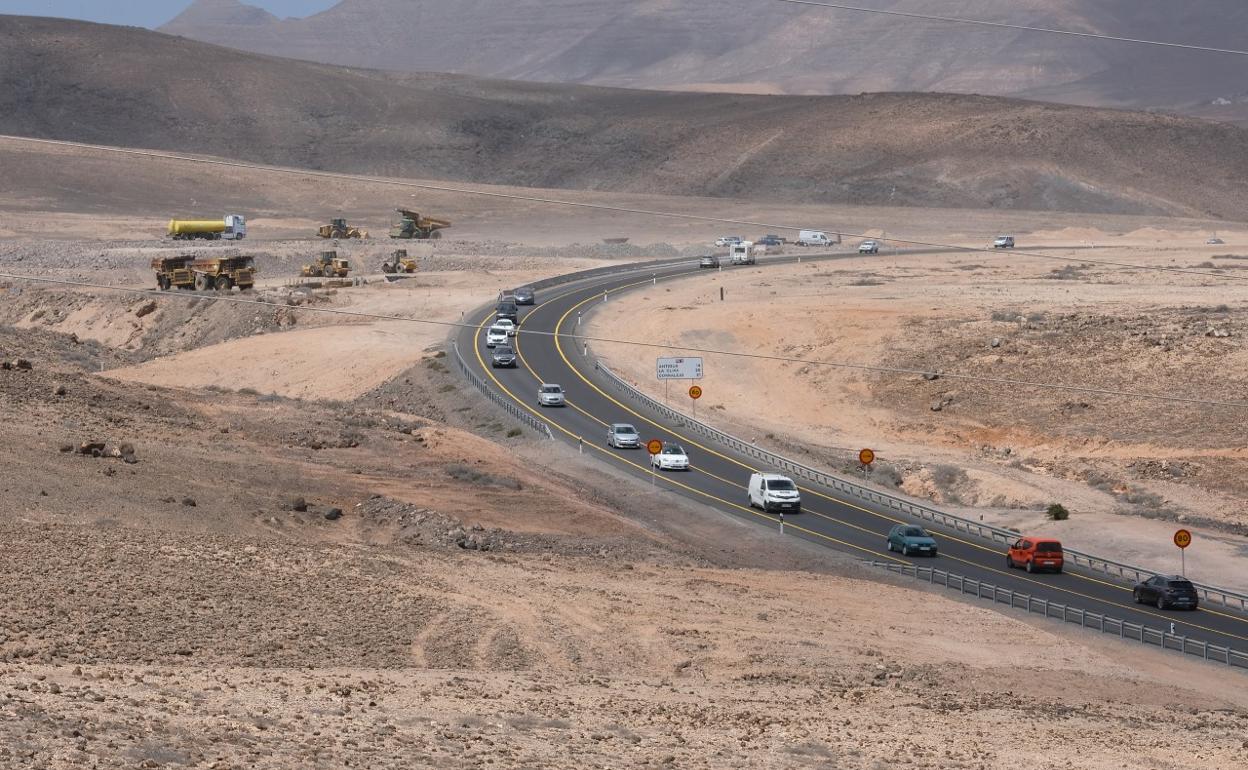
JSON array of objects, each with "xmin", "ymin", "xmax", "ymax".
[{"xmin": 7, "ymin": 134, "xmax": 1248, "ymax": 281}]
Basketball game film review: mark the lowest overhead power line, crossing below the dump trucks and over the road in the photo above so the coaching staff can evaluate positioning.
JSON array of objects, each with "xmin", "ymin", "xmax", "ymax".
[{"xmin": 0, "ymin": 273, "xmax": 1248, "ymax": 409}]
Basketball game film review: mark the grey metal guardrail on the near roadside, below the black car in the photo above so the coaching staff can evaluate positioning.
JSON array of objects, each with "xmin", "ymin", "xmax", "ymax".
[{"xmin": 866, "ymin": 562, "xmax": 1248, "ymax": 669}]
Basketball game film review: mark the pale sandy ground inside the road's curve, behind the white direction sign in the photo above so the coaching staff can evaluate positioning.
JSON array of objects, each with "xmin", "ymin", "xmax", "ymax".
[{"xmin": 590, "ymin": 234, "xmax": 1248, "ymax": 589}]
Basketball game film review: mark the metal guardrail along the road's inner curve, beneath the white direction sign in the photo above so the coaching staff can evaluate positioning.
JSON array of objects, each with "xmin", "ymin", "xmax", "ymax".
[{"xmin": 594, "ymin": 359, "xmax": 1248, "ymax": 612}]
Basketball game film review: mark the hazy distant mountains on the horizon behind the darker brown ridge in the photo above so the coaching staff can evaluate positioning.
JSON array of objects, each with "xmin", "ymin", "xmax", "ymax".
[{"xmin": 163, "ymin": 0, "xmax": 1248, "ymax": 120}]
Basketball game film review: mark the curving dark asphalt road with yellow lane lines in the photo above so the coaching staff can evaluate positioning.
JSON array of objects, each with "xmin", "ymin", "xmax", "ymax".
[{"xmin": 458, "ymin": 255, "xmax": 1248, "ymax": 653}]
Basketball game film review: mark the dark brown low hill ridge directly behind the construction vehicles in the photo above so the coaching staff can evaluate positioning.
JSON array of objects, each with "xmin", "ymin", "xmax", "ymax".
[{"xmin": 7, "ymin": 16, "xmax": 1248, "ymax": 218}]
